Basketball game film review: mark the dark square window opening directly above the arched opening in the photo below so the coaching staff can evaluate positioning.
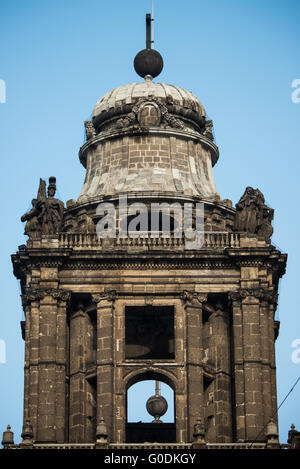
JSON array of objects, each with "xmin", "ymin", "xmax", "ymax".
[{"xmin": 125, "ymin": 306, "xmax": 175, "ymax": 360}]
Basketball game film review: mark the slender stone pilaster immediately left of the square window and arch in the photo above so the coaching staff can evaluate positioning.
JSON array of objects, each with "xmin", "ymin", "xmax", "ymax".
[{"xmin": 92, "ymin": 290, "xmax": 116, "ymax": 440}]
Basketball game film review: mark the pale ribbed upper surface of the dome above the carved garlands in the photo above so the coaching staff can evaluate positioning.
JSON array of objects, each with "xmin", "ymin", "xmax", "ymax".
[{"xmin": 93, "ymin": 80, "xmax": 205, "ymax": 119}]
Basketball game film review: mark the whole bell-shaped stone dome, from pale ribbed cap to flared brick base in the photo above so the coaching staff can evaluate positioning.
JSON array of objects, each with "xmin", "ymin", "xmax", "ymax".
[{"xmin": 78, "ymin": 76, "xmax": 219, "ymax": 203}]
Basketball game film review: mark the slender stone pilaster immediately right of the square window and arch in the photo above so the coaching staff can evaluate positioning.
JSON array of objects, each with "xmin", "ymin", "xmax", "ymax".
[{"xmin": 183, "ymin": 291, "xmax": 207, "ymax": 441}]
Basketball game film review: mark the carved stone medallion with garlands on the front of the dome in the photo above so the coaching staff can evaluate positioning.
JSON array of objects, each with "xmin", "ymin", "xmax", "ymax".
[{"xmin": 116, "ymin": 96, "xmax": 185, "ymax": 130}]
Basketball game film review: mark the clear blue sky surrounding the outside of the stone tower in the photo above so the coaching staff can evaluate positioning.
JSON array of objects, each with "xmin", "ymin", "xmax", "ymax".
[{"xmin": 0, "ymin": 0, "xmax": 300, "ymax": 442}]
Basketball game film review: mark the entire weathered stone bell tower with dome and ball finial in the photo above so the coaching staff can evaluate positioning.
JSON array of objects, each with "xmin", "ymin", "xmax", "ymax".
[{"xmin": 12, "ymin": 15, "xmax": 286, "ymax": 447}]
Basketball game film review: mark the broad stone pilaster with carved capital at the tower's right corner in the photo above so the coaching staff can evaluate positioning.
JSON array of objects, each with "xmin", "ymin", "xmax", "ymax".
[{"xmin": 231, "ymin": 287, "xmax": 265, "ymax": 441}]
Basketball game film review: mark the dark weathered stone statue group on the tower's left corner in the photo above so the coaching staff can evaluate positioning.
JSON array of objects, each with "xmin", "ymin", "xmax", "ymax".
[{"xmin": 21, "ymin": 176, "xmax": 64, "ymax": 238}]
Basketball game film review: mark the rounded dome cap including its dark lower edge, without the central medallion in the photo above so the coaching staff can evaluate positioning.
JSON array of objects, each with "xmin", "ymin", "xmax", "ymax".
[{"xmin": 92, "ymin": 76, "xmax": 206, "ymax": 129}]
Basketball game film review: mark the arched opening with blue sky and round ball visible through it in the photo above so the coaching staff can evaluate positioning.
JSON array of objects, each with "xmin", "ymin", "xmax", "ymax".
[{"xmin": 126, "ymin": 371, "xmax": 176, "ymax": 443}]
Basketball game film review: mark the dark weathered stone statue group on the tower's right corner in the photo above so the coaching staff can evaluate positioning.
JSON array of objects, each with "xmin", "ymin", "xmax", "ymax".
[{"xmin": 234, "ymin": 187, "xmax": 274, "ymax": 242}]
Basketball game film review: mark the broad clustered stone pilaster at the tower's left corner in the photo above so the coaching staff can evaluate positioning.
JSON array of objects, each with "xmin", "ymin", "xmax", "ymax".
[{"xmin": 23, "ymin": 288, "xmax": 70, "ymax": 442}]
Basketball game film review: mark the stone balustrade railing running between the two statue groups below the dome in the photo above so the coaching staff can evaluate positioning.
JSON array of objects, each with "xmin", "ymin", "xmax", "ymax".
[{"xmin": 59, "ymin": 232, "xmax": 240, "ymax": 251}]
